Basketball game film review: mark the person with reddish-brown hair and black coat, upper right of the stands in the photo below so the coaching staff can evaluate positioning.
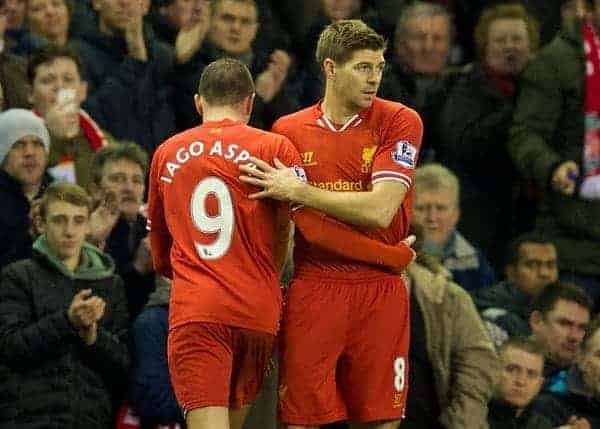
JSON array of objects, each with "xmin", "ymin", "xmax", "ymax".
[{"xmin": 436, "ymin": 4, "xmax": 539, "ymax": 269}]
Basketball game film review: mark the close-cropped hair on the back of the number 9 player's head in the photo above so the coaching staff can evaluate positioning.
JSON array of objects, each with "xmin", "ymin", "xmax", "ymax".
[{"xmin": 198, "ymin": 58, "xmax": 254, "ymax": 106}]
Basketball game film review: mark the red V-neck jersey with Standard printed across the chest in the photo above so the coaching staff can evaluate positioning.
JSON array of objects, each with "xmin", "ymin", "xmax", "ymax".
[{"xmin": 273, "ymin": 98, "xmax": 423, "ymax": 278}]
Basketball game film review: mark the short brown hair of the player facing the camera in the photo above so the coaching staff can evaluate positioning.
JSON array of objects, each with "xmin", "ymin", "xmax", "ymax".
[{"xmin": 315, "ymin": 19, "xmax": 387, "ymax": 67}]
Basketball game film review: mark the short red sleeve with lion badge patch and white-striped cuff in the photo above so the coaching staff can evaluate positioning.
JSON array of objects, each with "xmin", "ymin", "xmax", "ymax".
[{"xmin": 371, "ymin": 108, "xmax": 423, "ymax": 188}]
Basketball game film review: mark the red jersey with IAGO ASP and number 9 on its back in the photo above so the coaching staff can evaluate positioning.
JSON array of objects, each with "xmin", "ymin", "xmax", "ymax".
[{"xmin": 148, "ymin": 120, "xmax": 301, "ymax": 333}]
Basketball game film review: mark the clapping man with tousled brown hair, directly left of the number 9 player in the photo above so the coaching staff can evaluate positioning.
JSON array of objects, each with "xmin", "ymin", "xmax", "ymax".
[{"xmin": 88, "ymin": 142, "xmax": 154, "ymax": 320}]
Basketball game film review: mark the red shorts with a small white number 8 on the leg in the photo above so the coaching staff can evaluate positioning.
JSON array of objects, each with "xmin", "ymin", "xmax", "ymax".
[{"xmin": 279, "ymin": 276, "xmax": 410, "ymax": 426}]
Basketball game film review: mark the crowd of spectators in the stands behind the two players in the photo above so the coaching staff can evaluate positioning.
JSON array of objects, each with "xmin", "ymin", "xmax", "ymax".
[{"xmin": 0, "ymin": 0, "xmax": 600, "ymax": 429}]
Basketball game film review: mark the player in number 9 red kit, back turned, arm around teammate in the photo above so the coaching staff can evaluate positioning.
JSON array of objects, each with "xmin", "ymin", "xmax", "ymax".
[{"xmin": 148, "ymin": 59, "xmax": 413, "ymax": 429}]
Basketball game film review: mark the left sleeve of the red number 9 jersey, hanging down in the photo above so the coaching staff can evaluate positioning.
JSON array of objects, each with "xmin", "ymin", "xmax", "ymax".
[{"xmin": 147, "ymin": 150, "xmax": 173, "ymax": 278}]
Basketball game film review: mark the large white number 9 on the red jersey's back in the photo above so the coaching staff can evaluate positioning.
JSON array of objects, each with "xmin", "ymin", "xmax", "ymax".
[{"xmin": 190, "ymin": 177, "xmax": 235, "ymax": 260}]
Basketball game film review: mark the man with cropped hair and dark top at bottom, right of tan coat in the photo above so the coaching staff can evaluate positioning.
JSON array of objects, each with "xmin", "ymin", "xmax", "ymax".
[{"xmin": 488, "ymin": 337, "xmax": 554, "ymax": 429}]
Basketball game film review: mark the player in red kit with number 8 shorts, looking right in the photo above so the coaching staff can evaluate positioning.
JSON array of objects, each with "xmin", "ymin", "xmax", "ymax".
[{"xmin": 240, "ymin": 20, "xmax": 423, "ymax": 428}]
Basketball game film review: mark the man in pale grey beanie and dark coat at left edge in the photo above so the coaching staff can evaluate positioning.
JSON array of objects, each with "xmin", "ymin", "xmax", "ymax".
[{"xmin": 0, "ymin": 109, "xmax": 50, "ymax": 268}]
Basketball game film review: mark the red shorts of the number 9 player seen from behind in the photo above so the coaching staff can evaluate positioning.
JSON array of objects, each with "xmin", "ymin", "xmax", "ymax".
[{"xmin": 167, "ymin": 323, "xmax": 275, "ymax": 411}]
